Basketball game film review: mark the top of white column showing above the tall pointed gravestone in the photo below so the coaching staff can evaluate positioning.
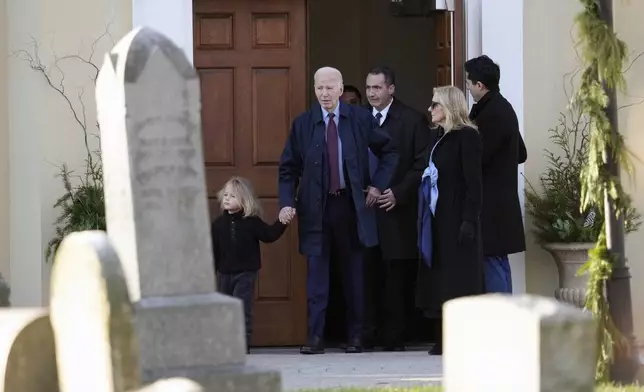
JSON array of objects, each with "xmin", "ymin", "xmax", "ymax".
[{"xmin": 132, "ymin": 0, "xmax": 193, "ymax": 63}]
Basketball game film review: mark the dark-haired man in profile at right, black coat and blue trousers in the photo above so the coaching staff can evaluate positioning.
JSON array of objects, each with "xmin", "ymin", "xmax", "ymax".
[{"xmin": 465, "ymin": 56, "xmax": 528, "ymax": 293}]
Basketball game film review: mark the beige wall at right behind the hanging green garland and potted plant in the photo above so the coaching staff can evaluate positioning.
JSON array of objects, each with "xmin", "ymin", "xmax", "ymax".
[{"xmin": 524, "ymin": 0, "xmax": 644, "ymax": 341}]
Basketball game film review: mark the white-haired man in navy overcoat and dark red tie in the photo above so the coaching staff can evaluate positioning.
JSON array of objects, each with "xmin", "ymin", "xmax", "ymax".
[{"xmin": 279, "ymin": 67, "xmax": 398, "ymax": 354}]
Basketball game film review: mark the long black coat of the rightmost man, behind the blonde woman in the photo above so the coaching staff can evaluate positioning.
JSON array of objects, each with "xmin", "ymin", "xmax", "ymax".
[{"xmin": 470, "ymin": 91, "xmax": 528, "ymax": 256}]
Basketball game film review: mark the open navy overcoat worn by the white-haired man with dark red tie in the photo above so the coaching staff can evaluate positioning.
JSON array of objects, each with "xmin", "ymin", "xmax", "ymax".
[{"xmin": 279, "ymin": 102, "xmax": 398, "ymax": 256}]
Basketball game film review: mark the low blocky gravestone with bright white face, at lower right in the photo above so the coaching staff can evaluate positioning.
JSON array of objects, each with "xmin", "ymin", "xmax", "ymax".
[{"xmin": 443, "ymin": 294, "xmax": 597, "ymax": 392}]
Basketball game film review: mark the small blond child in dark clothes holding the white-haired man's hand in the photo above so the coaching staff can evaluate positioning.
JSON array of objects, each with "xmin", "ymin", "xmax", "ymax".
[{"xmin": 211, "ymin": 177, "xmax": 286, "ymax": 353}]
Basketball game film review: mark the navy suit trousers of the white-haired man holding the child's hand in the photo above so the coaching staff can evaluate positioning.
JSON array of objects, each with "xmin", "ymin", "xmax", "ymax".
[{"xmin": 306, "ymin": 191, "xmax": 364, "ymax": 341}]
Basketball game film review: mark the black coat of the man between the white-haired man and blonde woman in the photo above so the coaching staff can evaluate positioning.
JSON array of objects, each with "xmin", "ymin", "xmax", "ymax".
[{"xmin": 376, "ymin": 98, "xmax": 430, "ymax": 260}]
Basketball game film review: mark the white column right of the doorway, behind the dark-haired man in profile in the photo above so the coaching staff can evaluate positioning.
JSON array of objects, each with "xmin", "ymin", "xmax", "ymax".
[{"xmin": 466, "ymin": 0, "xmax": 534, "ymax": 294}]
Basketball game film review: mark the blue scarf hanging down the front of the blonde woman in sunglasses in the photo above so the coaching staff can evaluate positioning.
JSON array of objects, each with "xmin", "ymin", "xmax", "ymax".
[{"xmin": 418, "ymin": 135, "xmax": 444, "ymax": 268}]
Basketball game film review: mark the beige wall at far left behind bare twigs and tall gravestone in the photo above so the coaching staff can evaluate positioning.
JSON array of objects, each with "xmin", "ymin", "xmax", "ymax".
[{"xmin": 5, "ymin": 0, "xmax": 132, "ymax": 305}]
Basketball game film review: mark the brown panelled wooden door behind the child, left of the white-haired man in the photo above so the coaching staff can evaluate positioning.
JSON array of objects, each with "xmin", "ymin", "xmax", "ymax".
[{"xmin": 193, "ymin": 0, "xmax": 307, "ymax": 346}]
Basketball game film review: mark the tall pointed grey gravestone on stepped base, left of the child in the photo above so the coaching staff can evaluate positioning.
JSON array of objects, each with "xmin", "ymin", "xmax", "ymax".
[{"xmin": 96, "ymin": 28, "xmax": 281, "ymax": 392}]
